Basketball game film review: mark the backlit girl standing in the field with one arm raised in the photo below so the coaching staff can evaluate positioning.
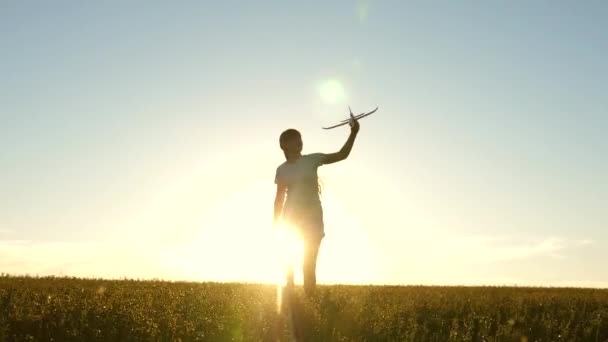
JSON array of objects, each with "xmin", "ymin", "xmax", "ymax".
[{"xmin": 274, "ymin": 115, "xmax": 359, "ymax": 295}]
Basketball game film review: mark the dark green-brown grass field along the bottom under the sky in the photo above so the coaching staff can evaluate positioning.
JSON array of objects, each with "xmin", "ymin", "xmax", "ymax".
[{"xmin": 0, "ymin": 275, "xmax": 608, "ymax": 341}]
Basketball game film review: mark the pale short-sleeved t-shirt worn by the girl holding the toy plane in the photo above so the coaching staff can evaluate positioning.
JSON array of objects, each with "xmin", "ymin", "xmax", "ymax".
[{"xmin": 274, "ymin": 153, "xmax": 324, "ymax": 216}]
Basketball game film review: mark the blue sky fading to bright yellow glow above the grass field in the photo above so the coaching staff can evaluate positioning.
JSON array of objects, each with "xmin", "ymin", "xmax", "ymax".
[{"xmin": 0, "ymin": 0, "xmax": 608, "ymax": 287}]
